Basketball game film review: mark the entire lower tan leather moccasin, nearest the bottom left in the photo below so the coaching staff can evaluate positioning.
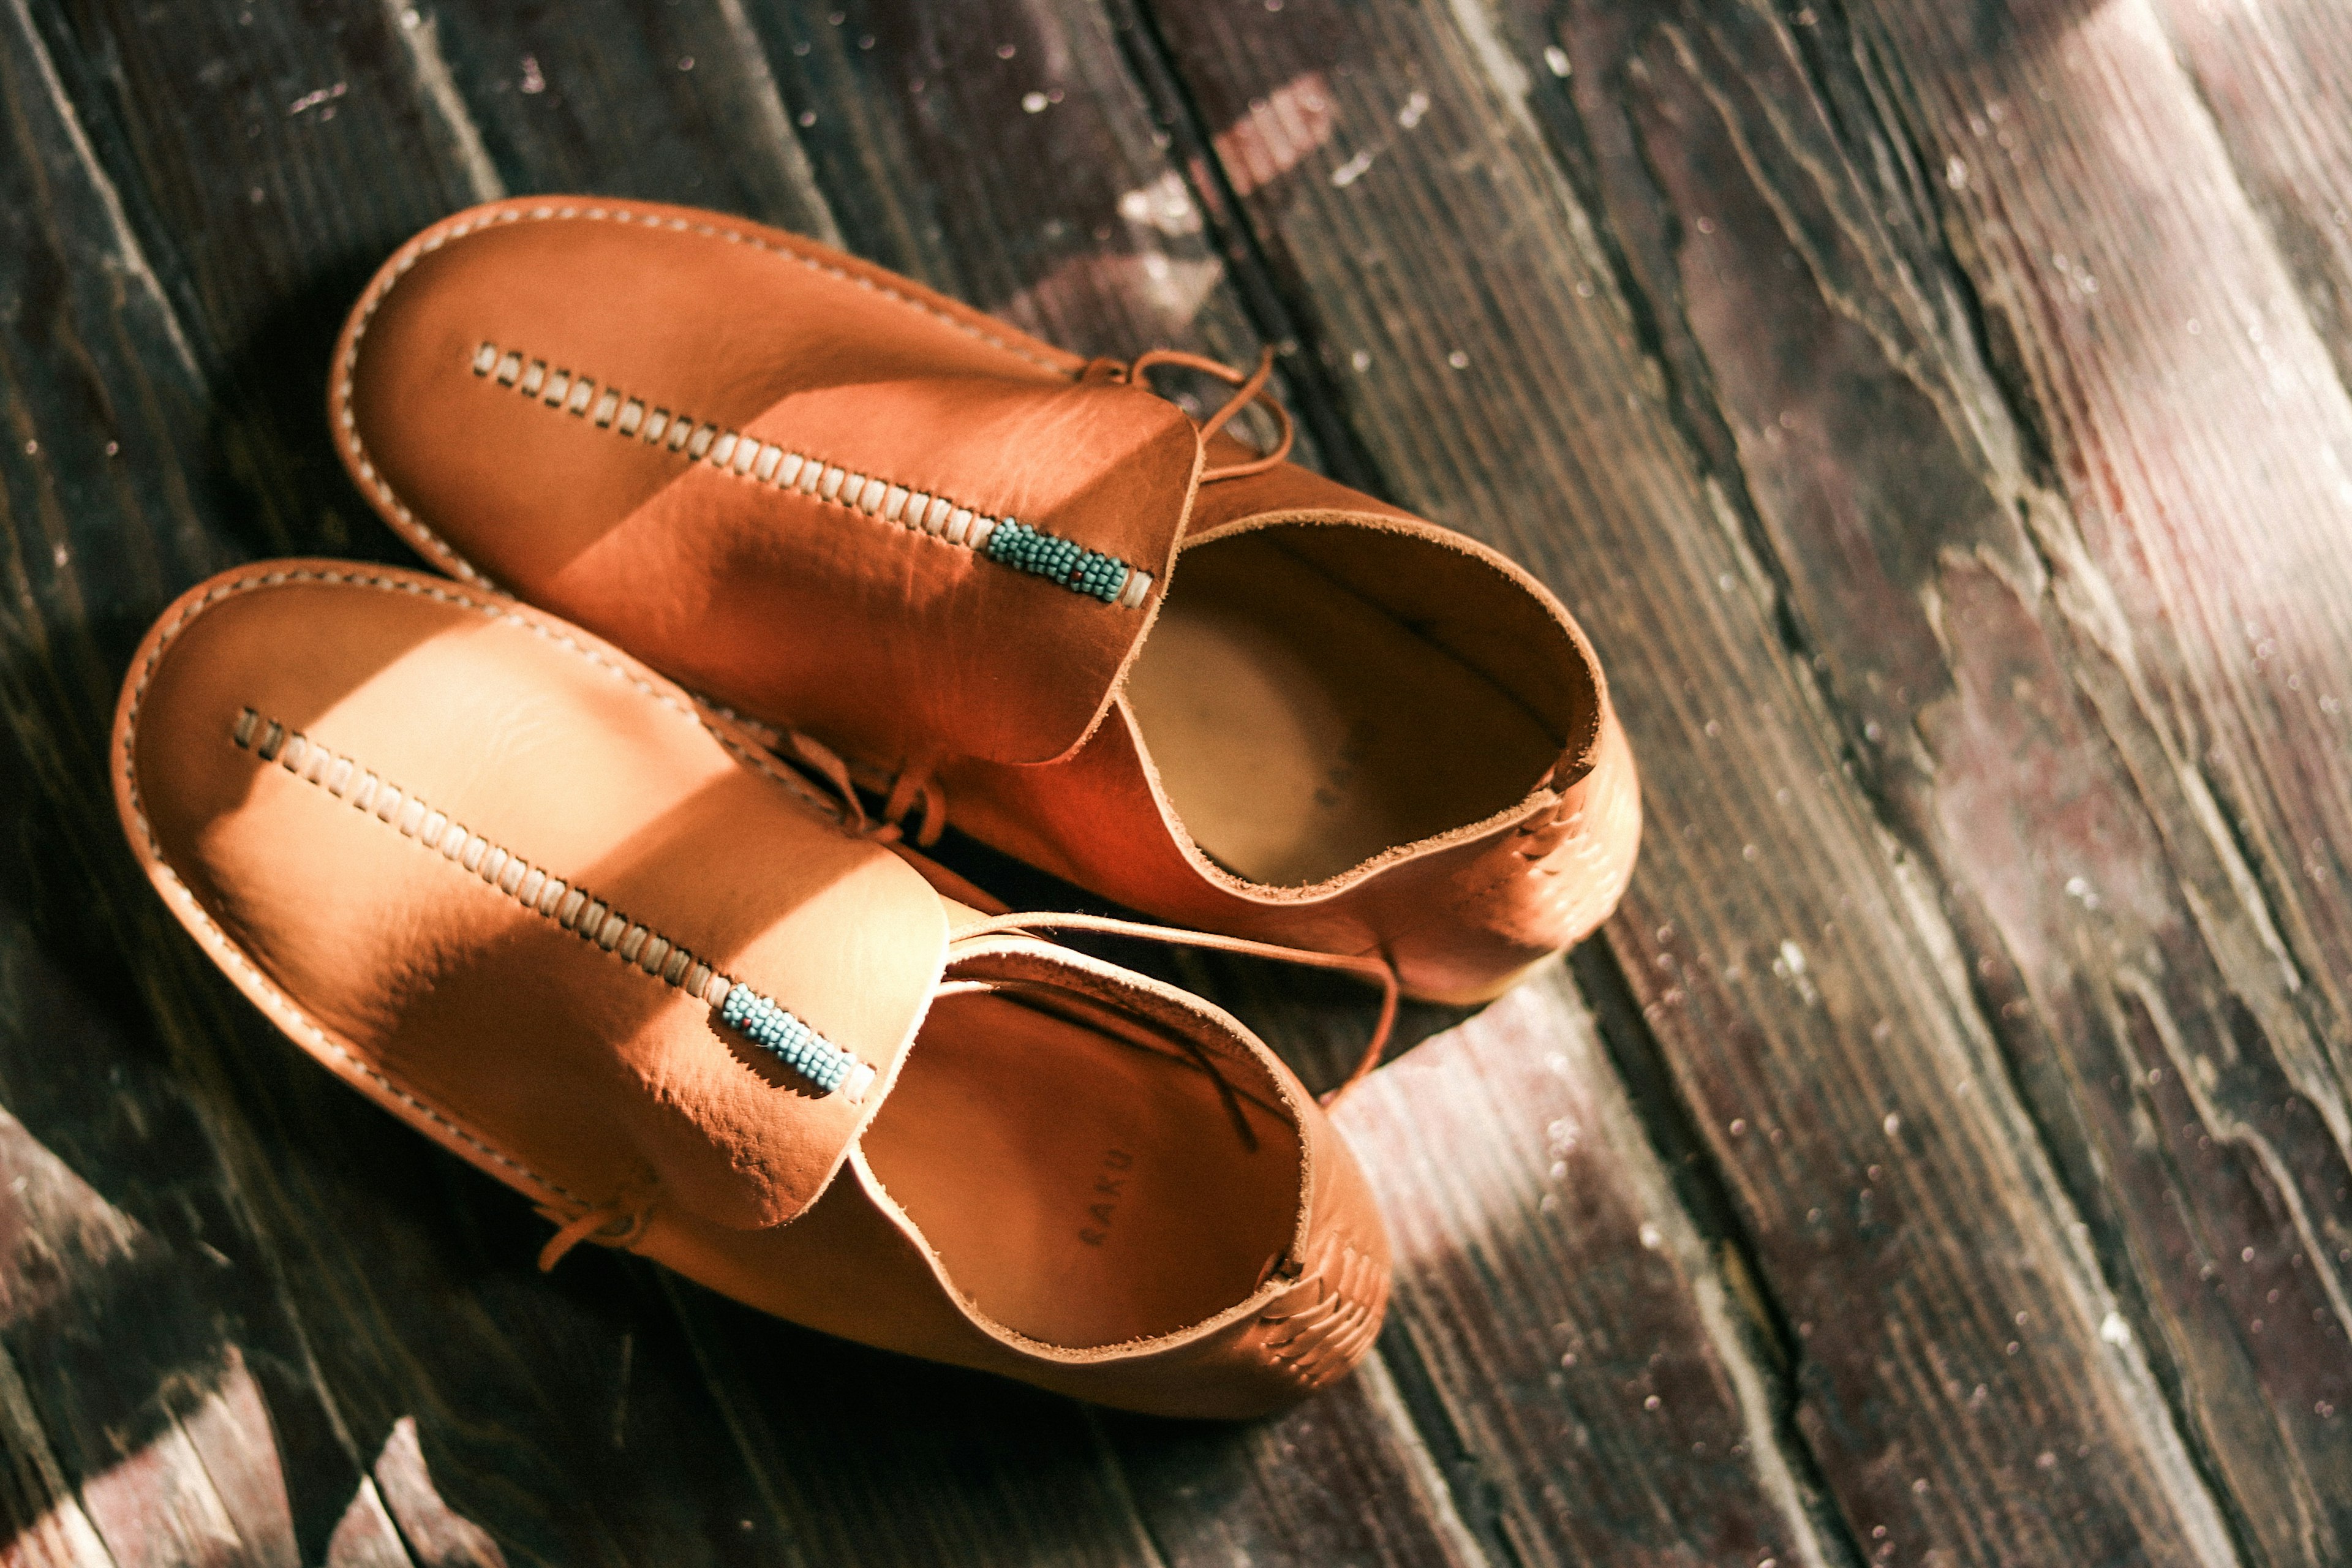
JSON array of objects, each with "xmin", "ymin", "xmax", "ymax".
[{"xmin": 113, "ymin": 562, "xmax": 1388, "ymax": 1415}]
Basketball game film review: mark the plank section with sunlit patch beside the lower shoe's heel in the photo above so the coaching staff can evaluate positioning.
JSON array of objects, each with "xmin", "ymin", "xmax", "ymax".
[{"xmin": 1341, "ymin": 973, "xmax": 1846, "ymax": 1568}]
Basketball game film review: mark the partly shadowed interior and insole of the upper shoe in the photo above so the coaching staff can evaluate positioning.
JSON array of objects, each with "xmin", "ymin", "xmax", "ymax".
[{"xmin": 1126, "ymin": 524, "xmax": 1597, "ymax": 886}]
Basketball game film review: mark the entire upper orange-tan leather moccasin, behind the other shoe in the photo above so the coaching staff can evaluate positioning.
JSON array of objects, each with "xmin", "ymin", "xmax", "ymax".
[{"xmin": 330, "ymin": 197, "xmax": 1639, "ymax": 1001}]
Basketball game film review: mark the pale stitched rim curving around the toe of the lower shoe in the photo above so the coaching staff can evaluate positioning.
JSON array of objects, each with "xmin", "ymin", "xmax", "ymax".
[{"xmin": 123, "ymin": 571, "xmax": 875, "ymax": 1204}]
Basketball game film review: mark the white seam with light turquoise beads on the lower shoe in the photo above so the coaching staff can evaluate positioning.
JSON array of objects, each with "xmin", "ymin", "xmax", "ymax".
[{"xmin": 228, "ymin": 707, "xmax": 873, "ymax": 1100}]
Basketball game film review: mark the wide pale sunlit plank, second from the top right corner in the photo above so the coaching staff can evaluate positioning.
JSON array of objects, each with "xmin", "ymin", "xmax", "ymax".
[{"xmin": 1856, "ymin": 5, "xmax": 2352, "ymax": 1175}]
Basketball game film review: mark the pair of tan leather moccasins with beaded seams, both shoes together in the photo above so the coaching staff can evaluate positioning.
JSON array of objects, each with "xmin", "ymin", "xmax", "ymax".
[{"xmin": 115, "ymin": 197, "xmax": 1639, "ymax": 1415}]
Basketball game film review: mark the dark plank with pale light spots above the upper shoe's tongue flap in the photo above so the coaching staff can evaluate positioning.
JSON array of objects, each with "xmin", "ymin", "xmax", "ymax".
[{"xmin": 755, "ymin": 0, "xmax": 1258, "ymax": 371}]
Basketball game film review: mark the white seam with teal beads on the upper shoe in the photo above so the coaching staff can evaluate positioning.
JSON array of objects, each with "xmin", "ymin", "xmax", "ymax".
[{"xmin": 468, "ymin": 339, "xmax": 1153, "ymax": 609}]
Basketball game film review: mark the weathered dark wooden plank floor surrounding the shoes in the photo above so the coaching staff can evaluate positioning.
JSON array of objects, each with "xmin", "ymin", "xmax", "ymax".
[{"xmin": 0, "ymin": 0, "xmax": 2352, "ymax": 1568}]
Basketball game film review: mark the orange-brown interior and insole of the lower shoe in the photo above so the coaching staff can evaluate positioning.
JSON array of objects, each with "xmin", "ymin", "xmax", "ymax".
[{"xmin": 863, "ymin": 985, "xmax": 1301, "ymax": 1349}]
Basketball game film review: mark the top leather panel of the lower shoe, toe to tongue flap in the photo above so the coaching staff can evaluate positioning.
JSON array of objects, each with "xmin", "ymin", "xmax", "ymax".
[{"xmin": 129, "ymin": 562, "xmax": 946, "ymax": 1227}]
